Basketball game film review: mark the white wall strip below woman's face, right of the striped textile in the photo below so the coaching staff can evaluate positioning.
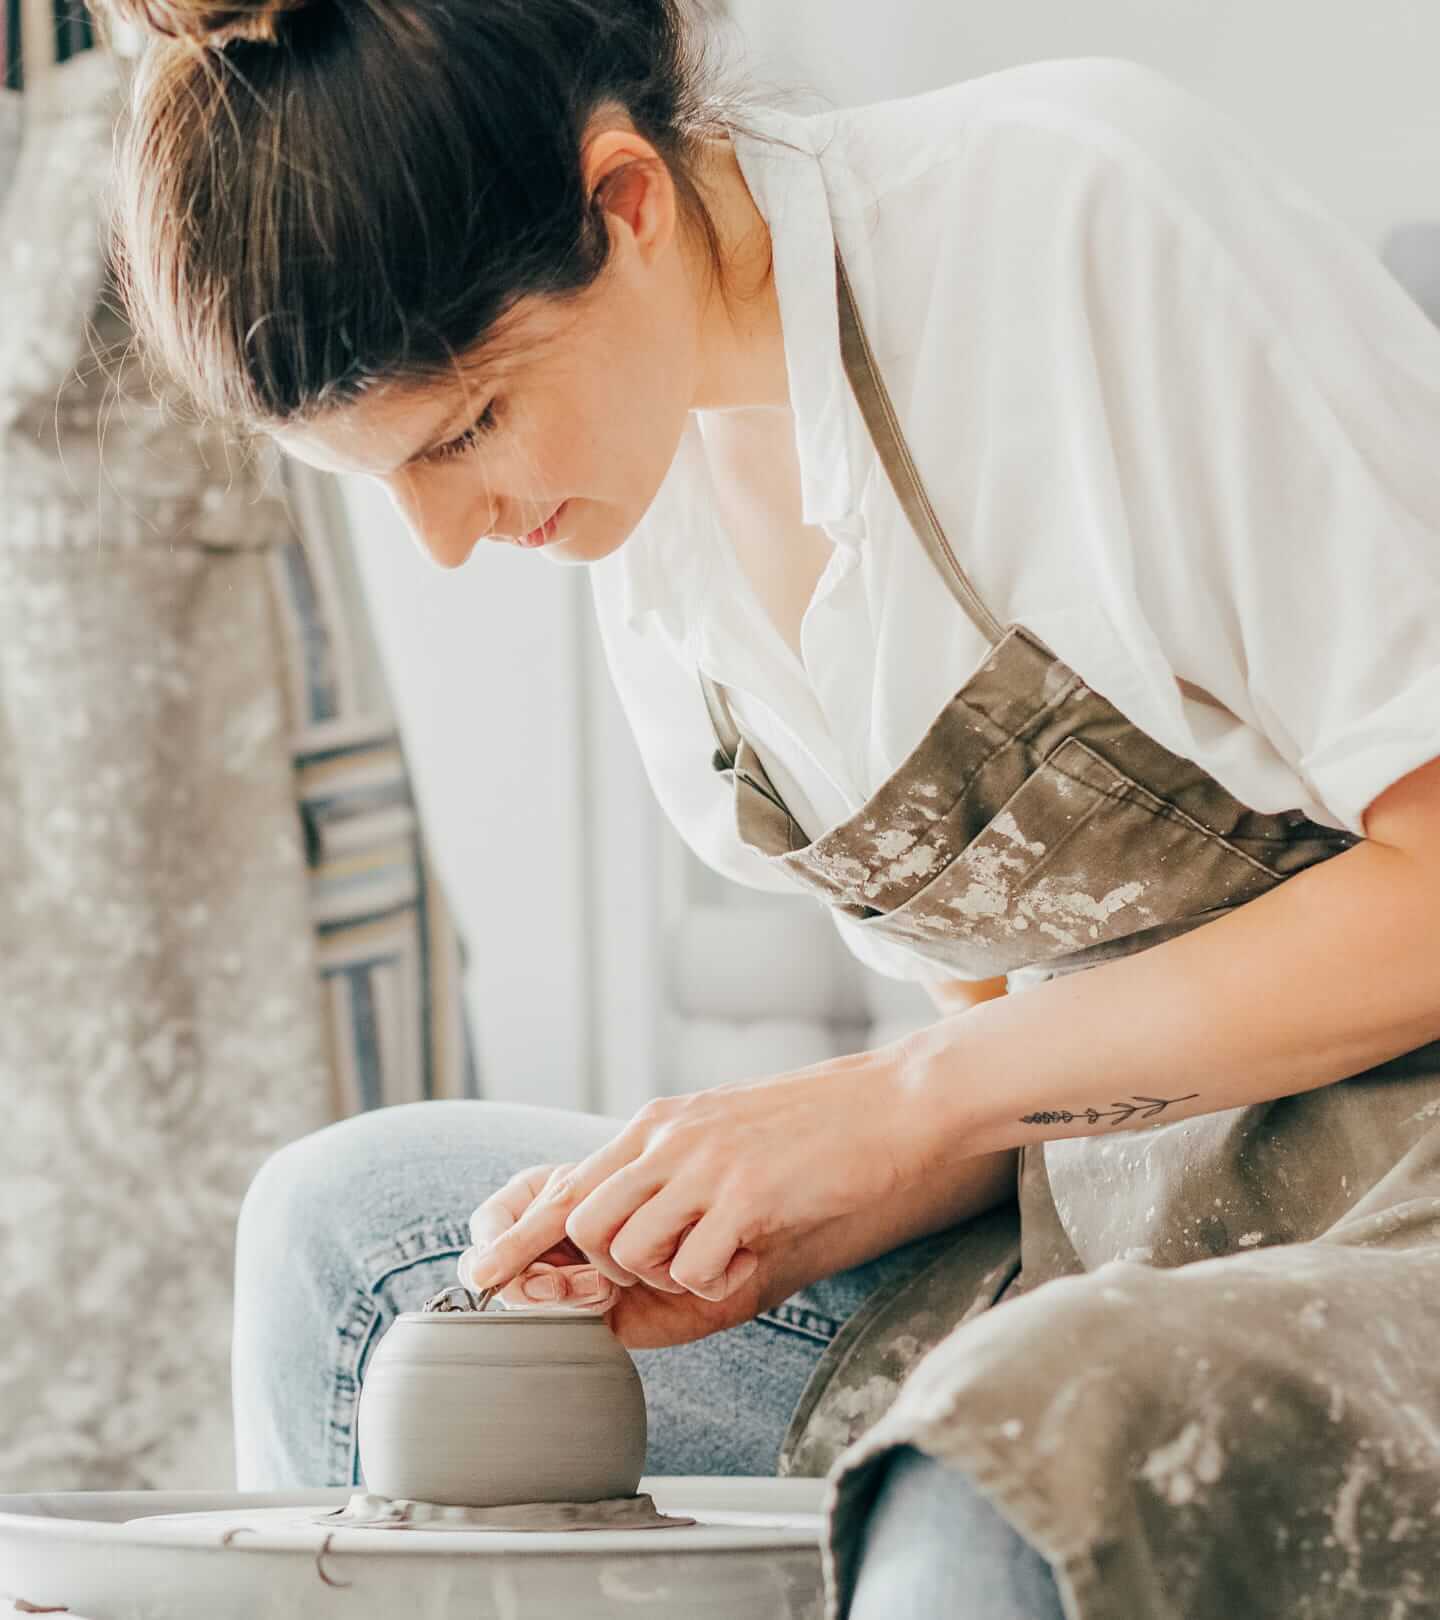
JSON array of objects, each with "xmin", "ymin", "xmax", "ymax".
[{"xmin": 343, "ymin": 480, "xmax": 591, "ymax": 1106}]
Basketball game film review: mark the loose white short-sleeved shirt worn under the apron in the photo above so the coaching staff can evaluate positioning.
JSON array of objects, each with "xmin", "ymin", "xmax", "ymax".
[{"xmin": 590, "ymin": 57, "xmax": 1440, "ymax": 978}]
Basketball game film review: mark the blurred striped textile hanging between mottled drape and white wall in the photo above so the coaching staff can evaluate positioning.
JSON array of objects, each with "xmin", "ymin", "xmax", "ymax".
[{"xmin": 261, "ymin": 452, "xmax": 481, "ymax": 1118}]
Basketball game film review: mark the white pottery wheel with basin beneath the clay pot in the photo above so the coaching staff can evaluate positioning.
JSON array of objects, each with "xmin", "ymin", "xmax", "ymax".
[{"xmin": 0, "ymin": 1476, "xmax": 824, "ymax": 1620}]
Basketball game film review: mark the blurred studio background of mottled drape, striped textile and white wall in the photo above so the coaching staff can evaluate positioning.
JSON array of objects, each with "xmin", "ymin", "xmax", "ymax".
[{"xmin": 0, "ymin": 0, "xmax": 1440, "ymax": 1490}]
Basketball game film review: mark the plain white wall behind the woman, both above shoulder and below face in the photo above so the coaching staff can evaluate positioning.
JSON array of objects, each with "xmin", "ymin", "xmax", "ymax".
[{"xmin": 347, "ymin": 0, "xmax": 1440, "ymax": 1113}]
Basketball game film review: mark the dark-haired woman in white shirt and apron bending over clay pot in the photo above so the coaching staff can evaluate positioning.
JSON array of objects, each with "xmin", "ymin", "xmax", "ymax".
[{"xmin": 98, "ymin": 0, "xmax": 1440, "ymax": 1620}]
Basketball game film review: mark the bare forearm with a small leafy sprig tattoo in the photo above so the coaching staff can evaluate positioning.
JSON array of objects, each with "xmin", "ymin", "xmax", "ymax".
[{"xmin": 889, "ymin": 841, "xmax": 1440, "ymax": 1170}]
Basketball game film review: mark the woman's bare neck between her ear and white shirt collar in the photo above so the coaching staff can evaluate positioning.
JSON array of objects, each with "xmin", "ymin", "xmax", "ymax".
[{"xmin": 690, "ymin": 138, "xmax": 790, "ymax": 411}]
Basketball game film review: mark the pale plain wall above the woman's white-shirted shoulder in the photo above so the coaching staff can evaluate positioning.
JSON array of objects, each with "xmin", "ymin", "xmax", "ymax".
[{"xmin": 731, "ymin": 0, "xmax": 1440, "ymax": 243}]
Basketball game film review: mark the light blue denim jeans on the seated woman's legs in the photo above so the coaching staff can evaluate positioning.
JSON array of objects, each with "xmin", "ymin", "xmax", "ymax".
[{"xmin": 232, "ymin": 1100, "xmax": 1063, "ymax": 1620}]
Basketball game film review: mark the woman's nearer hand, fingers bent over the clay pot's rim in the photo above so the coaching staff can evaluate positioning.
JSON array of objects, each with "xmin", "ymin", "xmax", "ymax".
[{"xmin": 467, "ymin": 1053, "xmax": 925, "ymax": 1299}]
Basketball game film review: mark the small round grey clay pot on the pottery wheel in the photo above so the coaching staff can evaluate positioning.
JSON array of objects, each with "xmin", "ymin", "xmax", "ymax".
[{"xmin": 356, "ymin": 1311, "xmax": 646, "ymax": 1508}]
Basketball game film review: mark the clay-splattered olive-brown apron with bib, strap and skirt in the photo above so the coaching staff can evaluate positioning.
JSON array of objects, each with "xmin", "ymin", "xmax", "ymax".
[{"xmin": 701, "ymin": 243, "xmax": 1440, "ymax": 1620}]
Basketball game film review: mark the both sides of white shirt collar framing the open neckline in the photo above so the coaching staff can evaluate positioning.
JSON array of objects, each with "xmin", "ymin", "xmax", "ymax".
[{"xmin": 609, "ymin": 98, "xmax": 860, "ymax": 650}]
